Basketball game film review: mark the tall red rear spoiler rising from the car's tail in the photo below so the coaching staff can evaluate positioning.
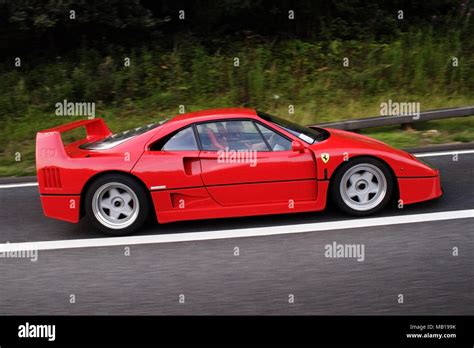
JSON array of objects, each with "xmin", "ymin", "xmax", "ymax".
[{"xmin": 36, "ymin": 118, "xmax": 112, "ymax": 162}]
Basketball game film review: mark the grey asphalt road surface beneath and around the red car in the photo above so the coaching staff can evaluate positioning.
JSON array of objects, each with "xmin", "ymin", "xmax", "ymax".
[{"xmin": 0, "ymin": 154, "xmax": 474, "ymax": 315}]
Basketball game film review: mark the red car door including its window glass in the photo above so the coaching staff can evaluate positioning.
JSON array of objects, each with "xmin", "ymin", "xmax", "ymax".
[{"xmin": 196, "ymin": 119, "xmax": 317, "ymax": 206}]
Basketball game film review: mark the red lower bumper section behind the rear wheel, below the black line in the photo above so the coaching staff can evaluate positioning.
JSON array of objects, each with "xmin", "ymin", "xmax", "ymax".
[{"xmin": 41, "ymin": 195, "xmax": 80, "ymax": 223}]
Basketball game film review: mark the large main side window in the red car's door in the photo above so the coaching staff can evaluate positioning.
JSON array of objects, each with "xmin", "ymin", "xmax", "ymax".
[{"xmin": 197, "ymin": 120, "xmax": 269, "ymax": 151}]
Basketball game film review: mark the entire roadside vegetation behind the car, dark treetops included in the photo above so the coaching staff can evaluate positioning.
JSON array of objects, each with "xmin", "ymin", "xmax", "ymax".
[{"xmin": 0, "ymin": 0, "xmax": 474, "ymax": 176}]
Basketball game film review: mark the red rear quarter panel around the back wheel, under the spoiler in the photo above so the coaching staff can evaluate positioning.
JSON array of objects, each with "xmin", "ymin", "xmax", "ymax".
[{"xmin": 36, "ymin": 126, "xmax": 159, "ymax": 222}]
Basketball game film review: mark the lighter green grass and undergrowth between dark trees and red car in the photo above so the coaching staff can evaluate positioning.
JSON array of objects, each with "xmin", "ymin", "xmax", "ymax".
[{"xmin": 0, "ymin": 28, "xmax": 474, "ymax": 174}]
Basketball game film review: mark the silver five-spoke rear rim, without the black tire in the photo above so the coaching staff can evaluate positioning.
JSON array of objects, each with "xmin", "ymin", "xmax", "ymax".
[{"xmin": 92, "ymin": 182, "xmax": 140, "ymax": 229}]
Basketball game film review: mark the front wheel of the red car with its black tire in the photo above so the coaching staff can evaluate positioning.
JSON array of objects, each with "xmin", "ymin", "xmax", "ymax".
[{"xmin": 330, "ymin": 157, "xmax": 394, "ymax": 216}]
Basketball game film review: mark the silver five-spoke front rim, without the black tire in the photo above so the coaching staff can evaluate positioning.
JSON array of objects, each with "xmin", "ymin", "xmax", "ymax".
[{"xmin": 339, "ymin": 163, "xmax": 387, "ymax": 211}]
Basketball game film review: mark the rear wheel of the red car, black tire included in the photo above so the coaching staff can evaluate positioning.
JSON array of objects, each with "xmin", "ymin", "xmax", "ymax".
[{"xmin": 84, "ymin": 173, "xmax": 150, "ymax": 236}]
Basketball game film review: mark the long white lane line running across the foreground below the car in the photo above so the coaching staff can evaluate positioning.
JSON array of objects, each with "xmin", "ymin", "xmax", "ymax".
[{"xmin": 0, "ymin": 209, "xmax": 474, "ymax": 252}]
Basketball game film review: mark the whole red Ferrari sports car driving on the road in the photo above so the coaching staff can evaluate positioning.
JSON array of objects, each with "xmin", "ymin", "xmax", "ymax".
[{"xmin": 36, "ymin": 108, "xmax": 442, "ymax": 235}]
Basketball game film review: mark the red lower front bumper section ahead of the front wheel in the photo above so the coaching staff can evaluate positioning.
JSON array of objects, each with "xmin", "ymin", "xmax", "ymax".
[{"xmin": 397, "ymin": 175, "xmax": 443, "ymax": 204}]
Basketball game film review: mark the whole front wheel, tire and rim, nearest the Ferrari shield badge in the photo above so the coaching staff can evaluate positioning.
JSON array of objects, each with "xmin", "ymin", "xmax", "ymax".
[{"xmin": 332, "ymin": 157, "xmax": 393, "ymax": 216}]
